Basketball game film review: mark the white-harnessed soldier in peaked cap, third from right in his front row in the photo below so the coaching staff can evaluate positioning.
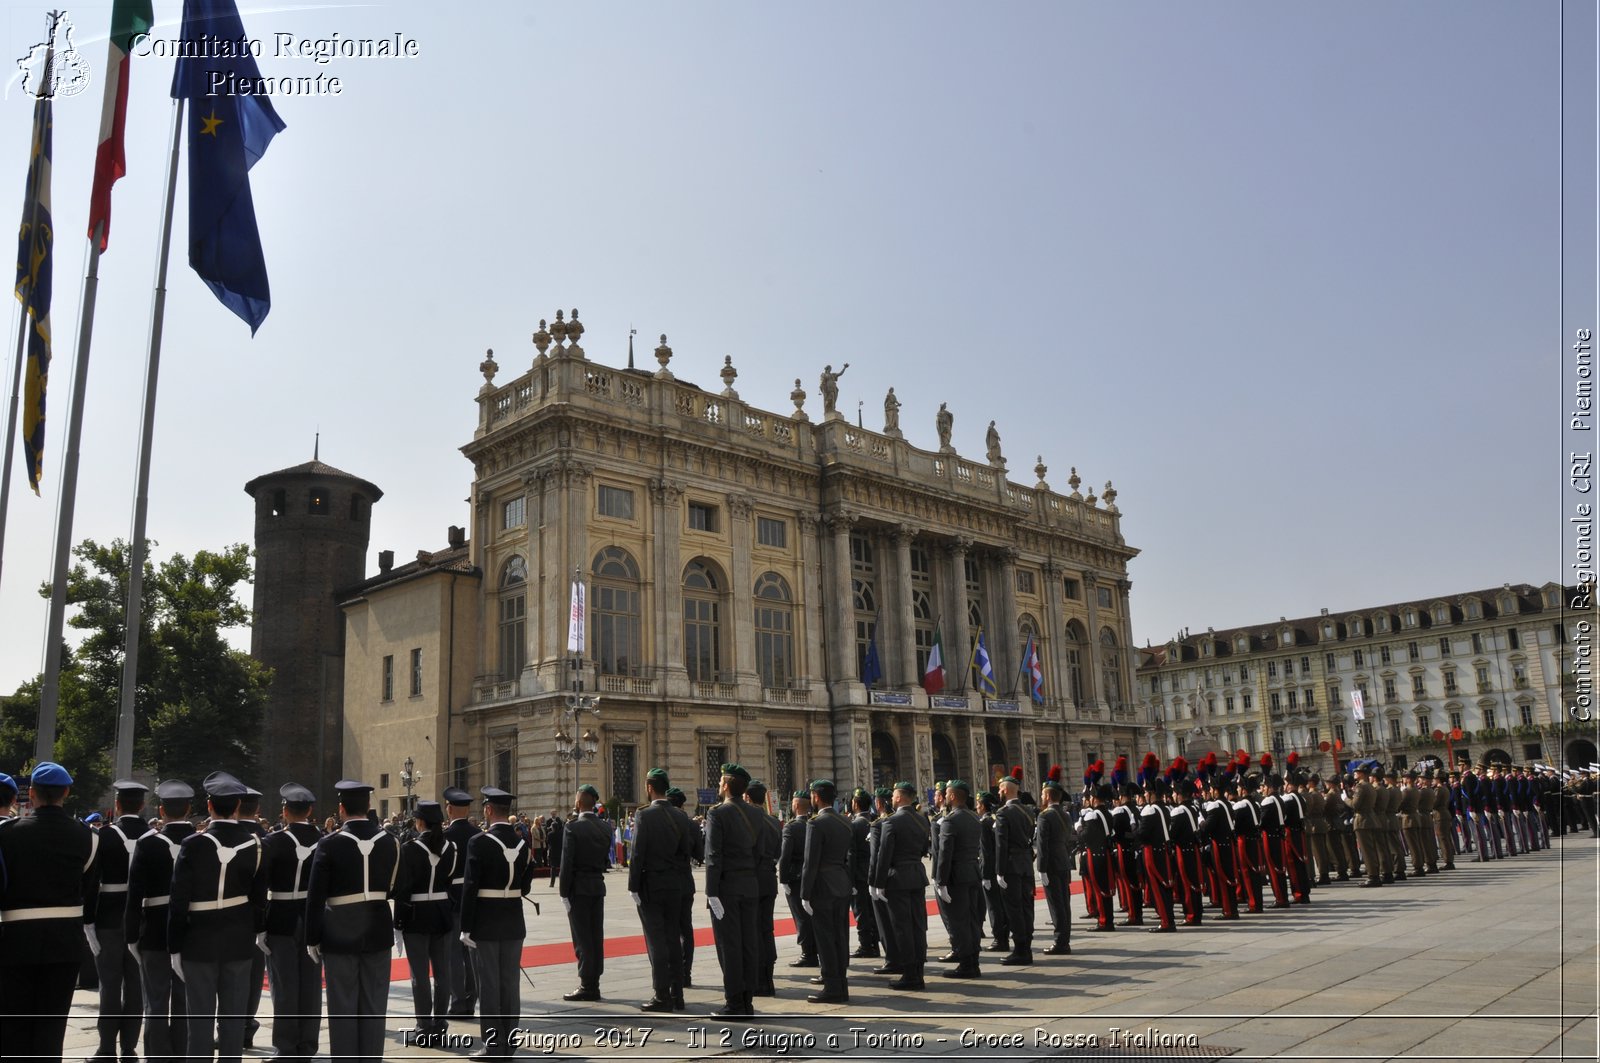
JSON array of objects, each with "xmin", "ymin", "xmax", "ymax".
[{"xmin": 306, "ymin": 780, "xmax": 400, "ymax": 1061}]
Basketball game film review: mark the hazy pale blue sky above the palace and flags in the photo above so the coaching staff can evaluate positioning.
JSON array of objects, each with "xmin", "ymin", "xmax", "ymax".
[{"xmin": 0, "ymin": 0, "xmax": 1568, "ymax": 690}]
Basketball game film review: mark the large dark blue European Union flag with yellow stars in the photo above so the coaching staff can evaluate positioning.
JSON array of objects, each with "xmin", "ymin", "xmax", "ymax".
[{"xmin": 173, "ymin": 0, "xmax": 283, "ymax": 336}]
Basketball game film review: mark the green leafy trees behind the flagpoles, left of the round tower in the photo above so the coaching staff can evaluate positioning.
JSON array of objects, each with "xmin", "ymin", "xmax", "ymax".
[{"xmin": 0, "ymin": 540, "xmax": 270, "ymax": 810}]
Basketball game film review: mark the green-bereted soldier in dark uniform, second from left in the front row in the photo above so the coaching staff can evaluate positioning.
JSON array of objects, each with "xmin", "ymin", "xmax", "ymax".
[{"xmin": 627, "ymin": 768, "xmax": 694, "ymax": 1012}]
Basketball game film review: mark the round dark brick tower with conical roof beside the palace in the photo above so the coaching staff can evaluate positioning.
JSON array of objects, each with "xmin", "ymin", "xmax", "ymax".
[{"xmin": 245, "ymin": 458, "xmax": 384, "ymax": 807}]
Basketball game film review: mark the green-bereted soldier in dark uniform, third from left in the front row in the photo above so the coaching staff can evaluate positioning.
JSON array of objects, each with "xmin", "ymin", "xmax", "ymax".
[{"xmin": 706, "ymin": 764, "xmax": 763, "ymax": 1018}]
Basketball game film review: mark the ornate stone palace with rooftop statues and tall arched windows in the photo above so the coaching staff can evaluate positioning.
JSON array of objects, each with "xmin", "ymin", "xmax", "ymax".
[{"xmin": 342, "ymin": 311, "xmax": 1149, "ymax": 812}]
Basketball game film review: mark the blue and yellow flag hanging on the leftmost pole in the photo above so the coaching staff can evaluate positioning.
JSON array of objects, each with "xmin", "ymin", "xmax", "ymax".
[{"xmin": 16, "ymin": 70, "xmax": 56, "ymax": 495}]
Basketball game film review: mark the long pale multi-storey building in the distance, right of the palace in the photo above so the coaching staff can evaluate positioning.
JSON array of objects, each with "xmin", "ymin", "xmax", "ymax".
[{"xmin": 1138, "ymin": 583, "xmax": 1595, "ymax": 772}]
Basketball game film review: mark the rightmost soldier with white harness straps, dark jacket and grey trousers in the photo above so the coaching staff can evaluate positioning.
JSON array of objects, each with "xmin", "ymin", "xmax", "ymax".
[{"xmin": 461, "ymin": 786, "xmax": 534, "ymax": 1060}]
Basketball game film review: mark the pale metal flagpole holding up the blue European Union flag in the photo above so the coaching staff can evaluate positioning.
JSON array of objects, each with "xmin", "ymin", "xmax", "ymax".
[{"xmin": 114, "ymin": 98, "xmax": 184, "ymax": 778}]
